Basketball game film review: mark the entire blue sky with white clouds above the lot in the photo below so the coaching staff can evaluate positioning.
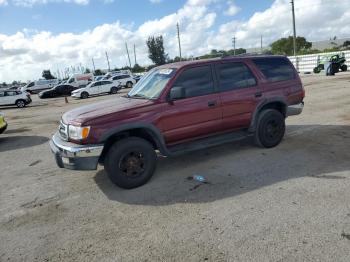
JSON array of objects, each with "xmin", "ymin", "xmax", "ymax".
[{"xmin": 0, "ymin": 0, "xmax": 350, "ymax": 82}]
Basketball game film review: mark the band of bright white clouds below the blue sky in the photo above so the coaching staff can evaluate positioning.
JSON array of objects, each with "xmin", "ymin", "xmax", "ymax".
[{"xmin": 0, "ymin": 0, "xmax": 350, "ymax": 82}]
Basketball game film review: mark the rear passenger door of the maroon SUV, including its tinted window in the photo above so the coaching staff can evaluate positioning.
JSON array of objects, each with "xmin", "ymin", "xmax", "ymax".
[{"xmin": 215, "ymin": 62, "xmax": 262, "ymax": 130}]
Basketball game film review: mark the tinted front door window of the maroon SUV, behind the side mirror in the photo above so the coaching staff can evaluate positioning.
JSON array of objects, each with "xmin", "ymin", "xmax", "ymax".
[{"xmin": 173, "ymin": 66, "xmax": 214, "ymax": 97}]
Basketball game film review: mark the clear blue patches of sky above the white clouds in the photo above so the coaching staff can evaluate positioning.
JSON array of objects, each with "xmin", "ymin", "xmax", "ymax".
[{"xmin": 0, "ymin": 0, "xmax": 273, "ymax": 34}]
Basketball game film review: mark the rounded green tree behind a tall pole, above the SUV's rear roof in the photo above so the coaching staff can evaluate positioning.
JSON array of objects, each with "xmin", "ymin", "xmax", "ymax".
[{"xmin": 271, "ymin": 36, "xmax": 312, "ymax": 55}]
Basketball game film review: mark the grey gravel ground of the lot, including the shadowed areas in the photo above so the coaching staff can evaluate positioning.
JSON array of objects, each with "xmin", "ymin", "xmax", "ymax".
[{"xmin": 0, "ymin": 73, "xmax": 350, "ymax": 262}]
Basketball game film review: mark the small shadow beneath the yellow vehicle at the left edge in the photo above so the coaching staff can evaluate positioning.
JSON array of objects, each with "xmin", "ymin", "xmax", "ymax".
[{"xmin": 0, "ymin": 135, "xmax": 49, "ymax": 153}]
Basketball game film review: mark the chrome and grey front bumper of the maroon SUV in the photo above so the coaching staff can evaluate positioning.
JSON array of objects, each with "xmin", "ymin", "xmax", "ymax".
[{"xmin": 50, "ymin": 133, "xmax": 103, "ymax": 170}]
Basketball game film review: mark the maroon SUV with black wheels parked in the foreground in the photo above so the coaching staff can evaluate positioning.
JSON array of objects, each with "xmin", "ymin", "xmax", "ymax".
[{"xmin": 50, "ymin": 56, "xmax": 305, "ymax": 188}]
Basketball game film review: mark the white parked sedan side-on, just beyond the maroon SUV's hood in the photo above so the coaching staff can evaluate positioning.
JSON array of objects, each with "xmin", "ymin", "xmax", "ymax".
[{"xmin": 72, "ymin": 80, "xmax": 121, "ymax": 99}]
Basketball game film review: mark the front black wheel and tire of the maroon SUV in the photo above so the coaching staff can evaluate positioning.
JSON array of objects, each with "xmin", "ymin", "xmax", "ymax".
[{"xmin": 104, "ymin": 137, "xmax": 157, "ymax": 189}]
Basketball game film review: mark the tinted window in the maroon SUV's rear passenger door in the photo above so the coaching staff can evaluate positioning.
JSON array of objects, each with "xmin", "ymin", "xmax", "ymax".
[{"xmin": 217, "ymin": 63, "xmax": 256, "ymax": 92}]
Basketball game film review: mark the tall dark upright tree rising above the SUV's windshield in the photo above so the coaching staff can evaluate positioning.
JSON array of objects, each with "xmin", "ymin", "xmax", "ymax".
[{"xmin": 146, "ymin": 36, "xmax": 168, "ymax": 66}]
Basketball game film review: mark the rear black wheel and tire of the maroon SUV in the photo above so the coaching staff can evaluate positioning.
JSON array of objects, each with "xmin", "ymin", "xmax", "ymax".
[{"xmin": 254, "ymin": 109, "xmax": 286, "ymax": 148}]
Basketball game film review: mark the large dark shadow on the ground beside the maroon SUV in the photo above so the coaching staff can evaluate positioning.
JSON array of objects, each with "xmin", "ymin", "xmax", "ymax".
[{"xmin": 94, "ymin": 125, "xmax": 350, "ymax": 205}]
